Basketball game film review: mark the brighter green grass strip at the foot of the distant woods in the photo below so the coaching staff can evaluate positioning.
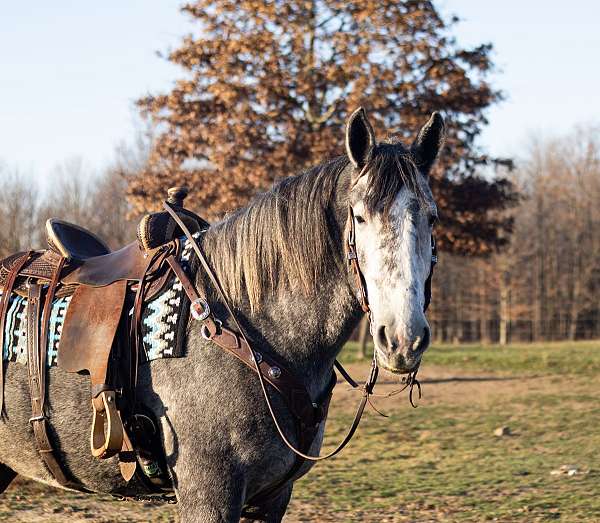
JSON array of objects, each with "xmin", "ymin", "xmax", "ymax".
[{"xmin": 341, "ymin": 341, "xmax": 600, "ymax": 375}]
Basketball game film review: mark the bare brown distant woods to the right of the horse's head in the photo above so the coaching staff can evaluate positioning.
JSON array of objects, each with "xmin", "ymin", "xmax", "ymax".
[{"xmin": 429, "ymin": 128, "xmax": 600, "ymax": 343}]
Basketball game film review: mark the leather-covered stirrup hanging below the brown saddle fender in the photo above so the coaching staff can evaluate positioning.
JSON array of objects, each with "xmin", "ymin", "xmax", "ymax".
[{"xmin": 90, "ymin": 390, "xmax": 123, "ymax": 459}]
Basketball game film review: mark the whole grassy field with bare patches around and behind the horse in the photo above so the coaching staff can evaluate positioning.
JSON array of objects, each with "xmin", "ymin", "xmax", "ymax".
[{"xmin": 0, "ymin": 343, "xmax": 600, "ymax": 523}]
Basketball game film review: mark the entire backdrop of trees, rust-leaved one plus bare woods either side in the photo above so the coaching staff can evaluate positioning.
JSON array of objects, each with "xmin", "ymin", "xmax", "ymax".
[{"xmin": 0, "ymin": 0, "xmax": 600, "ymax": 343}]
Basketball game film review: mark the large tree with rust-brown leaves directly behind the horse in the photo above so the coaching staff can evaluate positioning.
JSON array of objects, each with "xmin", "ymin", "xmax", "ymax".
[{"xmin": 129, "ymin": 0, "xmax": 515, "ymax": 253}]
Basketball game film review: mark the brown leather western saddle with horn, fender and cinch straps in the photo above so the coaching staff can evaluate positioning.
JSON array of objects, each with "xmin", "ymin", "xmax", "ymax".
[{"xmin": 0, "ymin": 187, "xmax": 209, "ymax": 491}]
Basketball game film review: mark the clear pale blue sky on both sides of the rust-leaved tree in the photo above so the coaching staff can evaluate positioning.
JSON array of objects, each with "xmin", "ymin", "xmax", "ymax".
[{"xmin": 0, "ymin": 0, "xmax": 600, "ymax": 185}]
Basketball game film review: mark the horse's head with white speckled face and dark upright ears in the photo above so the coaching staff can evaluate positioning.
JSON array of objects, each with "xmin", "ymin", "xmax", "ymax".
[{"xmin": 346, "ymin": 108, "xmax": 444, "ymax": 373}]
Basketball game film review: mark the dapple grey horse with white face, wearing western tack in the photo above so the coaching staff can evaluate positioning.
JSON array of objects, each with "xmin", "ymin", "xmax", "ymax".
[{"xmin": 0, "ymin": 108, "xmax": 444, "ymax": 523}]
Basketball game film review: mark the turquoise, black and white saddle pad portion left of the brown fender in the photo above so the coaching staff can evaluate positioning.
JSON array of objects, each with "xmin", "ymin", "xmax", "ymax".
[{"xmin": 0, "ymin": 292, "xmax": 71, "ymax": 367}]
